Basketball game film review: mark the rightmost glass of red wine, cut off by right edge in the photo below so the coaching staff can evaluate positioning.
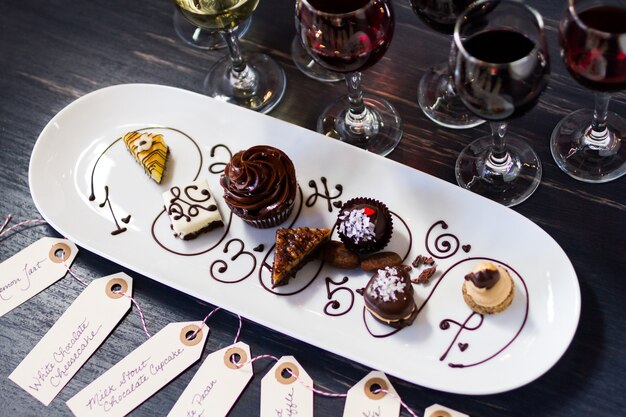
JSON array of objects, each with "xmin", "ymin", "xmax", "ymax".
[{"xmin": 550, "ymin": 0, "xmax": 626, "ymax": 183}]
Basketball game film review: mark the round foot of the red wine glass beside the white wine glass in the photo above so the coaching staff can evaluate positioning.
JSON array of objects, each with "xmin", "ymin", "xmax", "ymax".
[{"xmin": 317, "ymin": 93, "xmax": 402, "ymax": 156}]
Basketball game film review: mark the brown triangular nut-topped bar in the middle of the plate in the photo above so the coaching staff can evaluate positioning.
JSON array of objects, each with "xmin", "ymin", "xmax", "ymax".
[{"xmin": 272, "ymin": 227, "xmax": 331, "ymax": 287}]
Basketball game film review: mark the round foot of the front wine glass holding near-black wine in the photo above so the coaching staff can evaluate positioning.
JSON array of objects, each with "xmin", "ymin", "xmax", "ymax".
[{"xmin": 455, "ymin": 135, "xmax": 541, "ymax": 207}]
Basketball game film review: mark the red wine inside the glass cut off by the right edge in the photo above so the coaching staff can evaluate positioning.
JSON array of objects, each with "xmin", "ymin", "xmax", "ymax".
[{"xmin": 561, "ymin": 6, "xmax": 626, "ymax": 91}]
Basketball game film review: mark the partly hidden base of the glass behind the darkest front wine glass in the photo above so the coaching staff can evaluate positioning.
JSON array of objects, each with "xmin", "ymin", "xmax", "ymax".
[{"xmin": 417, "ymin": 62, "xmax": 485, "ymax": 129}]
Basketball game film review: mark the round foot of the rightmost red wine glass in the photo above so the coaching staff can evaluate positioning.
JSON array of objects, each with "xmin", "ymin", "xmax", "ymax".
[{"xmin": 550, "ymin": 109, "xmax": 626, "ymax": 183}]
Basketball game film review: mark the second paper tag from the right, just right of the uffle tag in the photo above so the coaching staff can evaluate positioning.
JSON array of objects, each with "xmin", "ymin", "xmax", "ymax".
[{"xmin": 343, "ymin": 371, "xmax": 400, "ymax": 417}]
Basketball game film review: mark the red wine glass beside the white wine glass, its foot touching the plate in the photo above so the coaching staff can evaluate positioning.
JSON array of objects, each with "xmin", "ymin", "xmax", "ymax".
[{"xmin": 296, "ymin": 0, "xmax": 402, "ymax": 155}]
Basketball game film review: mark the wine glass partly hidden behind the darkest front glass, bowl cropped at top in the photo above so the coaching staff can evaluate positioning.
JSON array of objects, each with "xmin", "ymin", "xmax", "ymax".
[{"xmin": 411, "ymin": 0, "xmax": 485, "ymax": 129}]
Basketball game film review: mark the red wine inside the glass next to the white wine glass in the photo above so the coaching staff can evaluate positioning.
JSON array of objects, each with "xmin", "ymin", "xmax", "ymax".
[{"xmin": 298, "ymin": 0, "xmax": 395, "ymax": 73}]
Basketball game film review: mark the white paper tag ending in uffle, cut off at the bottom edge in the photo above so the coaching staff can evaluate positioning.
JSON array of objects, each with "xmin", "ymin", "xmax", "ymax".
[{"xmin": 261, "ymin": 356, "xmax": 313, "ymax": 417}]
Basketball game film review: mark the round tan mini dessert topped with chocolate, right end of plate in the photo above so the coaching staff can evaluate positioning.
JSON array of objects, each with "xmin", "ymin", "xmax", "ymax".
[{"xmin": 463, "ymin": 262, "xmax": 515, "ymax": 314}]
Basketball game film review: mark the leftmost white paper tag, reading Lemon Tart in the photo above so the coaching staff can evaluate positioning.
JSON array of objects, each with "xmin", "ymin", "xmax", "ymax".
[{"xmin": 0, "ymin": 237, "xmax": 78, "ymax": 317}]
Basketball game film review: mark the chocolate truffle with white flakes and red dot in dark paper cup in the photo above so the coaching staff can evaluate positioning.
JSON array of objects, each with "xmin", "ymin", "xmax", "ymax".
[{"xmin": 337, "ymin": 197, "xmax": 393, "ymax": 255}]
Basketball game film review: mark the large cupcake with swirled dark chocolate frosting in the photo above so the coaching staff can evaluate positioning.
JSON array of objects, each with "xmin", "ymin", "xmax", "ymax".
[{"xmin": 220, "ymin": 145, "xmax": 298, "ymax": 228}]
